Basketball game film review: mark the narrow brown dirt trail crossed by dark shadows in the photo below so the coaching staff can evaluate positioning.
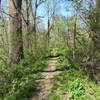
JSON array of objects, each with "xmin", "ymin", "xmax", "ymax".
[{"xmin": 31, "ymin": 57, "xmax": 58, "ymax": 100}]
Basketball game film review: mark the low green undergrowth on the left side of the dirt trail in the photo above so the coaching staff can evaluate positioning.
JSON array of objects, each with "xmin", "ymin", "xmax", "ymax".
[{"xmin": 0, "ymin": 57, "xmax": 48, "ymax": 100}]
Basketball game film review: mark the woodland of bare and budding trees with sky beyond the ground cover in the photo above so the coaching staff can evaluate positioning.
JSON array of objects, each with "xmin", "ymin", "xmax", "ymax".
[{"xmin": 0, "ymin": 0, "xmax": 100, "ymax": 99}]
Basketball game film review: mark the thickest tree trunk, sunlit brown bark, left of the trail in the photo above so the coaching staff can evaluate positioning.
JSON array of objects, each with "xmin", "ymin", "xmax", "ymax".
[{"xmin": 8, "ymin": 0, "xmax": 24, "ymax": 64}]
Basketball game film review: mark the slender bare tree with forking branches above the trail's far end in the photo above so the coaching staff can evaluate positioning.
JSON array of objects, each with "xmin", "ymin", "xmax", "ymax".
[{"xmin": 46, "ymin": 0, "xmax": 59, "ymax": 47}]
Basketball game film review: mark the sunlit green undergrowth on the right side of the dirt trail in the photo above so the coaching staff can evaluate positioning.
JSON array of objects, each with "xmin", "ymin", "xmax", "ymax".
[{"xmin": 49, "ymin": 56, "xmax": 100, "ymax": 100}]
